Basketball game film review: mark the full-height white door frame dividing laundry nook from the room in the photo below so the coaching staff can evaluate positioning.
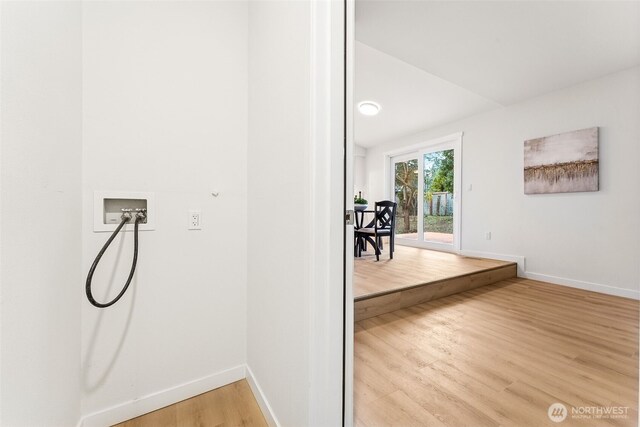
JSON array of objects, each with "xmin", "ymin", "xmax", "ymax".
[{"xmin": 304, "ymin": 0, "xmax": 355, "ymax": 427}]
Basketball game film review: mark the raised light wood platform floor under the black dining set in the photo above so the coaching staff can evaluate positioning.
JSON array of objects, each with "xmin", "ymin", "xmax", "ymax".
[{"xmin": 353, "ymin": 244, "xmax": 513, "ymax": 300}]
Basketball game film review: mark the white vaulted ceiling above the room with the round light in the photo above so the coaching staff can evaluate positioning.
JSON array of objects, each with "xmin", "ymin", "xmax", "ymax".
[{"xmin": 355, "ymin": 0, "xmax": 640, "ymax": 146}]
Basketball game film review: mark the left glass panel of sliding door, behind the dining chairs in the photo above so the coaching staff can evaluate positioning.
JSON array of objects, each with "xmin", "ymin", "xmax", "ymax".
[{"xmin": 393, "ymin": 157, "xmax": 419, "ymax": 240}]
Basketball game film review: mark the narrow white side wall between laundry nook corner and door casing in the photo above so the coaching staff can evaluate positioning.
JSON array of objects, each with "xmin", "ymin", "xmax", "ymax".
[{"xmin": 247, "ymin": 1, "xmax": 311, "ymax": 426}]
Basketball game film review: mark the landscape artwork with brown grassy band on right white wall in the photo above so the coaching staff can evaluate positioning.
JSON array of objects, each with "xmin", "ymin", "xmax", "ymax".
[{"xmin": 524, "ymin": 127, "xmax": 599, "ymax": 194}]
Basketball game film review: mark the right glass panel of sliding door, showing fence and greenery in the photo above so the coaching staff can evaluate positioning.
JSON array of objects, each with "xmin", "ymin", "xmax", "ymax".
[{"xmin": 422, "ymin": 150, "xmax": 454, "ymax": 245}]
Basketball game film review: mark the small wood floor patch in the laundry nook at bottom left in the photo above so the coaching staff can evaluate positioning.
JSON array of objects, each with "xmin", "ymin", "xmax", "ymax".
[{"xmin": 116, "ymin": 380, "xmax": 267, "ymax": 427}]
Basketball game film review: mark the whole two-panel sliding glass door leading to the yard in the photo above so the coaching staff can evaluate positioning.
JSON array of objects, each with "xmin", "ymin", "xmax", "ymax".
[{"xmin": 390, "ymin": 136, "xmax": 461, "ymax": 251}]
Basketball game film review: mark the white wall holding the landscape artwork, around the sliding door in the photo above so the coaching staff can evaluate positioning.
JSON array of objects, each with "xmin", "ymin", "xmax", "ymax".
[{"xmin": 367, "ymin": 68, "xmax": 640, "ymax": 297}]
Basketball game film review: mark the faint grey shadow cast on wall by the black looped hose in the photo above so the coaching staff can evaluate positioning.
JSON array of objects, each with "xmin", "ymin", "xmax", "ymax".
[{"xmin": 82, "ymin": 233, "xmax": 138, "ymax": 393}]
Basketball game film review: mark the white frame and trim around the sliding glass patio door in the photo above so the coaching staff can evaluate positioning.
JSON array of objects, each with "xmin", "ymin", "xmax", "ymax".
[{"xmin": 383, "ymin": 132, "xmax": 463, "ymax": 253}]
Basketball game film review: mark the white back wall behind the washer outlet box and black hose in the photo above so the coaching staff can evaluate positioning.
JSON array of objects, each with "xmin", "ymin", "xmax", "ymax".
[{"xmin": 82, "ymin": 1, "xmax": 250, "ymax": 424}]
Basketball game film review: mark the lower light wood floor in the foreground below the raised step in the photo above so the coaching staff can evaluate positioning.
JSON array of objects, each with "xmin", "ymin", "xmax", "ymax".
[{"xmin": 355, "ymin": 279, "xmax": 639, "ymax": 427}]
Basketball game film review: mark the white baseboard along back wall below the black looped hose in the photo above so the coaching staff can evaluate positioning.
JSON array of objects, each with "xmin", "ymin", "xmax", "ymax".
[{"xmin": 79, "ymin": 365, "xmax": 245, "ymax": 427}]
